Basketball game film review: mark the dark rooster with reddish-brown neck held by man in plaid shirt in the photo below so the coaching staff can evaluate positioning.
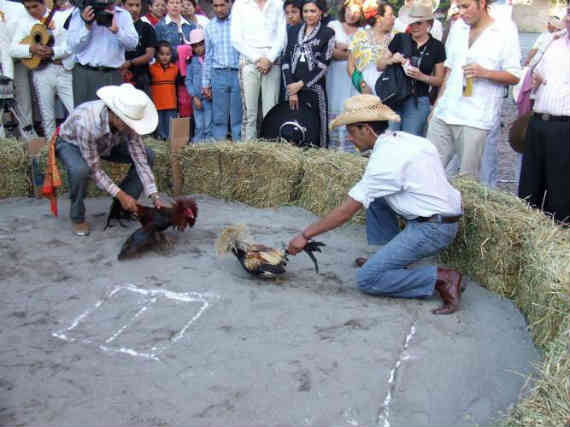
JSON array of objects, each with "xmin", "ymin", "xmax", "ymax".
[{"xmin": 105, "ymin": 197, "xmax": 198, "ymax": 260}]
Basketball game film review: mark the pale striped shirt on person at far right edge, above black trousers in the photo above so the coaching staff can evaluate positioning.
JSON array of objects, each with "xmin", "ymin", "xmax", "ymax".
[{"xmin": 533, "ymin": 35, "xmax": 570, "ymax": 116}]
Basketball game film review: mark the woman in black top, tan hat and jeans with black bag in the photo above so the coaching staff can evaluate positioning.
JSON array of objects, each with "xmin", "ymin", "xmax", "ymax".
[{"xmin": 378, "ymin": 2, "xmax": 445, "ymax": 136}]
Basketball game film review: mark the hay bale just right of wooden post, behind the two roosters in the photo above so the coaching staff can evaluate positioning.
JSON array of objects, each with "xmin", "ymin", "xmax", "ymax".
[{"xmin": 180, "ymin": 141, "xmax": 302, "ymax": 207}]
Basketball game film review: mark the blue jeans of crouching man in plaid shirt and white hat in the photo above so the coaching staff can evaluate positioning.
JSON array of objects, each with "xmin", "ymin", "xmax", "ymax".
[{"xmin": 55, "ymin": 138, "xmax": 154, "ymax": 224}]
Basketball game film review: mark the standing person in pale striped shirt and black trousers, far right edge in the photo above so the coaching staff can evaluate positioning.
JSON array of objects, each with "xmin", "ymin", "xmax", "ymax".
[{"xmin": 519, "ymin": 7, "xmax": 570, "ymax": 225}]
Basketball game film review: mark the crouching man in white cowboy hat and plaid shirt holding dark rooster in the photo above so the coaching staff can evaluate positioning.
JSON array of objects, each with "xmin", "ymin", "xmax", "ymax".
[{"xmin": 55, "ymin": 83, "xmax": 162, "ymax": 236}]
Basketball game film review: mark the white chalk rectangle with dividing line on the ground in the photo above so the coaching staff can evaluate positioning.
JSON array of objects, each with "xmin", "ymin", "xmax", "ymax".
[{"xmin": 52, "ymin": 284, "xmax": 219, "ymax": 360}]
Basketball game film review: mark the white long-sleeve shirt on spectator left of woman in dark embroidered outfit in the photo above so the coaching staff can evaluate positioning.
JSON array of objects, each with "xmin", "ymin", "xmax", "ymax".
[{"xmin": 230, "ymin": 0, "xmax": 287, "ymax": 62}]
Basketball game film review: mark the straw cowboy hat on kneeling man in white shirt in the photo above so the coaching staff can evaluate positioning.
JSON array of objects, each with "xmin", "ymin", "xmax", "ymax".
[{"xmin": 329, "ymin": 95, "xmax": 400, "ymax": 130}]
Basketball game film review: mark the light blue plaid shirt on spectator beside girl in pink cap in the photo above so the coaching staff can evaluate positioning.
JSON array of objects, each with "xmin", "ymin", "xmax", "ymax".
[{"xmin": 202, "ymin": 15, "xmax": 239, "ymax": 87}]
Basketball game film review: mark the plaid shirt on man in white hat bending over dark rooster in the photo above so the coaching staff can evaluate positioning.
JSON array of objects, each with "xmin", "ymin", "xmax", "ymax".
[{"xmin": 59, "ymin": 101, "xmax": 157, "ymax": 197}]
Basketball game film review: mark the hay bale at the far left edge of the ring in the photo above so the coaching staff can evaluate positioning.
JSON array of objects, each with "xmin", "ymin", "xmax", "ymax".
[{"xmin": 0, "ymin": 139, "xmax": 32, "ymax": 198}]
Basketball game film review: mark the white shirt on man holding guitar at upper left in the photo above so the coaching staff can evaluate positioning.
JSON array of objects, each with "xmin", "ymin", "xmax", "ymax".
[{"xmin": 10, "ymin": 10, "xmax": 71, "ymax": 60}]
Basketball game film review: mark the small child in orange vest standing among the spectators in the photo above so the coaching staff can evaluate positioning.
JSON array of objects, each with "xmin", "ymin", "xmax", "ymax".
[{"xmin": 149, "ymin": 40, "xmax": 178, "ymax": 140}]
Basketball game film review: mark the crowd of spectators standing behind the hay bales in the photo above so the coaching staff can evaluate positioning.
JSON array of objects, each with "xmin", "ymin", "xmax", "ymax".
[{"xmin": 0, "ymin": 0, "xmax": 570, "ymax": 224}]
